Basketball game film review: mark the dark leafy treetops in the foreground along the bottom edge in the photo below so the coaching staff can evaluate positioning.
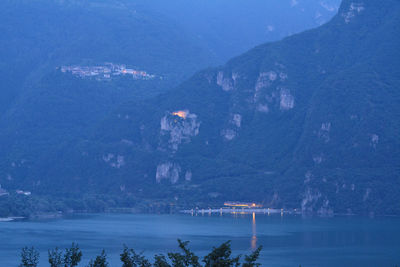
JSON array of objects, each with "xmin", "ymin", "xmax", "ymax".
[{"xmin": 19, "ymin": 240, "xmax": 262, "ymax": 267}]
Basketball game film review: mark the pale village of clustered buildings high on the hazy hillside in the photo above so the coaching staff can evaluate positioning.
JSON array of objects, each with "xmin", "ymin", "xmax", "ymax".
[{"xmin": 60, "ymin": 63, "xmax": 156, "ymax": 80}]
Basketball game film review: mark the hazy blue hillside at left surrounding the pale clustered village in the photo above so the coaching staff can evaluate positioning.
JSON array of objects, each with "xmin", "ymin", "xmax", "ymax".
[{"xmin": 0, "ymin": 0, "xmax": 215, "ymax": 203}]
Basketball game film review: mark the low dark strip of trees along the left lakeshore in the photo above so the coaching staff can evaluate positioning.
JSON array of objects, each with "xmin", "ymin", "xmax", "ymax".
[{"xmin": 0, "ymin": 193, "xmax": 180, "ymax": 219}]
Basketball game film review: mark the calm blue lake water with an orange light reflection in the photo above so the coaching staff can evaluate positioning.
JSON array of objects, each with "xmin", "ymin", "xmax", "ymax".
[{"xmin": 0, "ymin": 214, "xmax": 400, "ymax": 267}]
